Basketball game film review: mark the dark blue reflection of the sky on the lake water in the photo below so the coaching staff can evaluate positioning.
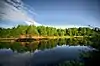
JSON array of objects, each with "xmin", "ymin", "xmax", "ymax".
[{"xmin": 0, "ymin": 45, "xmax": 92, "ymax": 66}]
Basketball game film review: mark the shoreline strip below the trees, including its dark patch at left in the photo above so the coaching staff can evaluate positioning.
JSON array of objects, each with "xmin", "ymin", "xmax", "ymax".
[{"xmin": 0, "ymin": 36, "xmax": 91, "ymax": 42}]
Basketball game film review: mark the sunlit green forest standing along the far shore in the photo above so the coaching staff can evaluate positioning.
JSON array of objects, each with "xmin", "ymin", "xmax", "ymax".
[{"xmin": 0, "ymin": 25, "xmax": 100, "ymax": 38}]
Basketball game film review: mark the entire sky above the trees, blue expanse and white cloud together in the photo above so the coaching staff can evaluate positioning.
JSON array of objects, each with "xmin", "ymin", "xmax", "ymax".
[{"xmin": 0, "ymin": 0, "xmax": 100, "ymax": 27}]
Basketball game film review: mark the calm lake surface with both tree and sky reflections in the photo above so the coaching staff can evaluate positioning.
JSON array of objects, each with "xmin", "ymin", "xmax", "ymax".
[{"xmin": 0, "ymin": 39, "xmax": 95, "ymax": 66}]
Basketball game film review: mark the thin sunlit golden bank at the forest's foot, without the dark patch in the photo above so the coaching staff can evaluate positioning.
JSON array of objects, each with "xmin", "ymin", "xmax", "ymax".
[{"xmin": 0, "ymin": 36, "xmax": 91, "ymax": 42}]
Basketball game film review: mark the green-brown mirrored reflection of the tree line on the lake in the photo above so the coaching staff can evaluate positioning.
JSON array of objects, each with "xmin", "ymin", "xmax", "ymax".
[{"xmin": 0, "ymin": 38, "xmax": 91, "ymax": 52}]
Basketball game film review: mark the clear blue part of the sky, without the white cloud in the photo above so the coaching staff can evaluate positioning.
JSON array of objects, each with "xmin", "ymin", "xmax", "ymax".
[{"xmin": 0, "ymin": 0, "xmax": 100, "ymax": 27}]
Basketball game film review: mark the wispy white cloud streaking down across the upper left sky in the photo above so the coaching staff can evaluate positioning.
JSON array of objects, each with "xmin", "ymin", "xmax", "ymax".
[{"xmin": 0, "ymin": 0, "xmax": 40, "ymax": 25}]
